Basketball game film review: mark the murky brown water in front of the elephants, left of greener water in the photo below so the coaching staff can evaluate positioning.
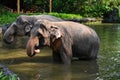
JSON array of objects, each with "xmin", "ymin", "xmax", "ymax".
[{"xmin": 0, "ymin": 48, "xmax": 98, "ymax": 80}]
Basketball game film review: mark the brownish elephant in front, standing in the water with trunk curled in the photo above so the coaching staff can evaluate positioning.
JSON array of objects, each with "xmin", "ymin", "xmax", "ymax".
[{"xmin": 26, "ymin": 20, "xmax": 100, "ymax": 64}]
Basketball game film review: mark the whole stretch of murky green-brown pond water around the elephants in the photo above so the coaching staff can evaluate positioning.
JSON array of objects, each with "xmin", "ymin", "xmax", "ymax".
[{"xmin": 0, "ymin": 24, "xmax": 120, "ymax": 80}]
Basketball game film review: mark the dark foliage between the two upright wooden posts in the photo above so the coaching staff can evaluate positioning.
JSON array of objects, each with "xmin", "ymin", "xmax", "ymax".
[{"xmin": 24, "ymin": 0, "xmax": 49, "ymax": 12}]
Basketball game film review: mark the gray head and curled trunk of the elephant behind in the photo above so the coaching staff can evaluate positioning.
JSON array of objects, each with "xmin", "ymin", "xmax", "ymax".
[{"xmin": 3, "ymin": 15, "xmax": 32, "ymax": 44}]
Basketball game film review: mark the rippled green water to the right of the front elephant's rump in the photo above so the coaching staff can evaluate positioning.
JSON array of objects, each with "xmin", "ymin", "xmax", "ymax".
[{"xmin": 89, "ymin": 24, "xmax": 120, "ymax": 80}]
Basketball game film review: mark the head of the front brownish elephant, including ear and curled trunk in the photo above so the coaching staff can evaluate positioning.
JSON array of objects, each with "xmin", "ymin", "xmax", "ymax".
[{"xmin": 26, "ymin": 20, "xmax": 62, "ymax": 57}]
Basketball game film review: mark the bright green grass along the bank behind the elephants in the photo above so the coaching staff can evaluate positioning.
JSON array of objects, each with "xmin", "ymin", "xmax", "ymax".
[{"xmin": 0, "ymin": 12, "xmax": 82, "ymax": 25}]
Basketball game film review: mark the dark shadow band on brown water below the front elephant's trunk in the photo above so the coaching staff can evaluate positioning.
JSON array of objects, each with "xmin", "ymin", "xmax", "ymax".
[{"xmin": 0, "ymin": 56, "xmax": 52, "ymax": 64}]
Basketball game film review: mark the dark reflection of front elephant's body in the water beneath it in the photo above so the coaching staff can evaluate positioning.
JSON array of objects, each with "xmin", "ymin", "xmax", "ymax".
[{"xmin": 41, "ymin": 61, "xmax": 98, "ymax": 80}]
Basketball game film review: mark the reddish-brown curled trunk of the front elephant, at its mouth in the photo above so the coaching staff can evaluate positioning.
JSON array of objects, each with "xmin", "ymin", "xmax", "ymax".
[{"xmin": 26, "ymin": 37, "xmax": 40, "ymax": 57}]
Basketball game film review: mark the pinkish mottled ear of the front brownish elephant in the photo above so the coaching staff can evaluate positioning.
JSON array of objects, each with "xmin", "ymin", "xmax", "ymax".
[{"xmin": 50, "ymin": 26, "xmax": 62, "ymax": 42}]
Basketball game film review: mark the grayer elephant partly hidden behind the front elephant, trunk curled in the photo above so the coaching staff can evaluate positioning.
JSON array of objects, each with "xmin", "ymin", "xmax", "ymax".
[{"xmin": 3, "ymin": 15, "xmax": 63, "ymax": 44}]
